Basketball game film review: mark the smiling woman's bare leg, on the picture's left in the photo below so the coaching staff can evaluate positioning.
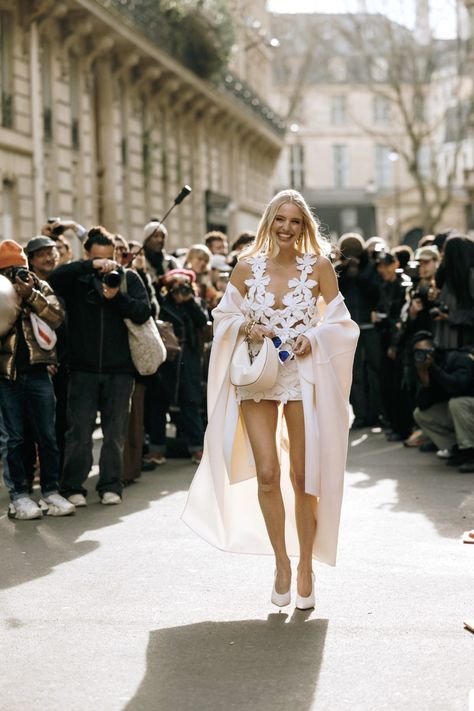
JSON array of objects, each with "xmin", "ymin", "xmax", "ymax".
[{"xmin": 241, "ymin": 400, "xmax": 291, "ymax": 594}]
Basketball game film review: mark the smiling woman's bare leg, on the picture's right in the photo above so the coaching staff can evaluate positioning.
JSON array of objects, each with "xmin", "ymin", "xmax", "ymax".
[{"xmin": 283, "ymin": 400, "xmax": 317, "ymax": 597}]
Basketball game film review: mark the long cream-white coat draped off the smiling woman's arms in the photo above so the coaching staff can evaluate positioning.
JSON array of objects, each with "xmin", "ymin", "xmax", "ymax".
[{"xmin": 183, "ymin": 284, "xmax": 359, "ymax": 565}]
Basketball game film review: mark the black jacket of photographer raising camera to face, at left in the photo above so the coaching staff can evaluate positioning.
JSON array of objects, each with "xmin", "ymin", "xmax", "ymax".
[{"xmin": 49, "ymin": 260, "xmax": 151, "ymax": 374}]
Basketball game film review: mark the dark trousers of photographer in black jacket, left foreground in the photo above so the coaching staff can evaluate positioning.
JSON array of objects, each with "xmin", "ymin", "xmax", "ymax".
[{"xmin": 61, "ymin": 372, "xmax": 135, "ymax": 497}]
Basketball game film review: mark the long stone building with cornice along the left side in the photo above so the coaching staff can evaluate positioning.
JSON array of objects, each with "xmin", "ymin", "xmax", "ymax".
[{"xmin": 0, "ymin": 0, "xmax": 284, "ymax": 248}]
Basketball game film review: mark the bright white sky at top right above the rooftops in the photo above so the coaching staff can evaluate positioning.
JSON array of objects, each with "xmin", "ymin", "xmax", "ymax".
[{"xmin": 268, "ymin": 0, "xmax": 456, "ymax": 37}]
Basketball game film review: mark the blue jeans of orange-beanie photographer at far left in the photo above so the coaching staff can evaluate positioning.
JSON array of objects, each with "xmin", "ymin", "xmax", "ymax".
[{"xmin": 0, "ymin": 370, "xmax": 59, "ymax": 501}]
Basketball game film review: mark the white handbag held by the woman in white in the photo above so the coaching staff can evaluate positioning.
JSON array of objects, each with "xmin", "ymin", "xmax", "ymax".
[{"xmin": 230, "ymin": 337, "xmax": 278, "ymax": 392}]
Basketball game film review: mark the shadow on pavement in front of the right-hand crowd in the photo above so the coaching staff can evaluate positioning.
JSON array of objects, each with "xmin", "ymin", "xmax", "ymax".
[{"xmin": 347, "ymin": 430, "xmax": 474, "ymax": 538}]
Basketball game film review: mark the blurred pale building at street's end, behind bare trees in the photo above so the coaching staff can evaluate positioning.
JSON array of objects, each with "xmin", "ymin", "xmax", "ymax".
[{"xmin": 272, "ymin": 9, "xmax": 469, "ymax": 244}]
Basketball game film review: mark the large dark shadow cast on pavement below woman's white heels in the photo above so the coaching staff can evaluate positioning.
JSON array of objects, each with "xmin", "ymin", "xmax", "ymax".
[{"xmin": 125, "ymin": 610, "xmax": 328, "ymax": 711}]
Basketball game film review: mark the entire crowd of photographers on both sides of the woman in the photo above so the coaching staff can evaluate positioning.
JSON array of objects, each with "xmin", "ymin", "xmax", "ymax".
[{"xmin": 0, "ymin": 218, "xmax": 474, "ymax": 519}]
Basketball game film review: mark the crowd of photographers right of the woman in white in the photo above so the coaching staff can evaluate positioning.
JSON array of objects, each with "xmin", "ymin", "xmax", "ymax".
[{"xmin": 336, "ymin": 231, "xmax": 474, "ymax": 473}]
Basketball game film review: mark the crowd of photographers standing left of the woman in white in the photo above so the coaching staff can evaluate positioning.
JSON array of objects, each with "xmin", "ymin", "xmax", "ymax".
[{"xmin": 0, "ymin": 218, "xmax": 253, "ymax": 519}]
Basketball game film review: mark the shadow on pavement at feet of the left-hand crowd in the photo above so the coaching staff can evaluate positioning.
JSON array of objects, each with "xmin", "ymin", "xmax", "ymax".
[{"xmin": 0, "ymin": 460, "xmax": 191, "ymax": 589}]
